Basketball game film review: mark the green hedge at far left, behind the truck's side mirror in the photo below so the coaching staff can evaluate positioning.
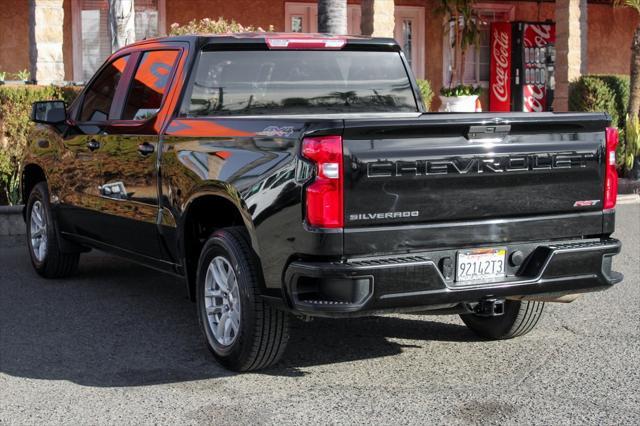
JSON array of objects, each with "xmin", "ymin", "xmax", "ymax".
[{"xmin": 0, "ymin": 85, "xmax": 81, "ymax": 205}]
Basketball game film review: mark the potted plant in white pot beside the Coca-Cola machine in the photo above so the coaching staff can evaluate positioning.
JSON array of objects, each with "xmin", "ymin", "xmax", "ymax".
[{"xmin": 439, "ymin": 0, "xmax": 480, "ymax": 112}]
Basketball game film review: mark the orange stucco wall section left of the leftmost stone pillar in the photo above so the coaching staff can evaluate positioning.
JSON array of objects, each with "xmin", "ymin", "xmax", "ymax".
[{"xmin": 0, "ymin": 0, "xmax": 29, "ymax": 75}]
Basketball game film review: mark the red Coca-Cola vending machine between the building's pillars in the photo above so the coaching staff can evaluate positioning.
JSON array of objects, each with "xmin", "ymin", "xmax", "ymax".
[{"xmin": 489, "ymin": 22, "xmax": 556, "ymax": 112}]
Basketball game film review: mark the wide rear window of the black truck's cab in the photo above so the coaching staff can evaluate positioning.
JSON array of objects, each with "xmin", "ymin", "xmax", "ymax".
[{"xmin": 182, "ymin": 51, "xmax": 417, "ymax": 116}]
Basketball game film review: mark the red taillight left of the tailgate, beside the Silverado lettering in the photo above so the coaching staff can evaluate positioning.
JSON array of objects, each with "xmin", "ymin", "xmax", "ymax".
[{"xmin": 302, "ymin": 136, "xmax": 344, "ymax": 228}]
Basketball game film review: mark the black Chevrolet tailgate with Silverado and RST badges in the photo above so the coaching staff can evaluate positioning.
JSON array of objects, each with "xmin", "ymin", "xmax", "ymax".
[{"xmin": 343, "ymin": 113, "xmax": 609, "ymax": 253}]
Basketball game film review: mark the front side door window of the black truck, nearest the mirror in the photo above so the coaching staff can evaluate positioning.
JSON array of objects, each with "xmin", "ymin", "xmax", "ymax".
[{"xmin": 80, "ymin": 55, "xmax": 129, "ymax": 121}]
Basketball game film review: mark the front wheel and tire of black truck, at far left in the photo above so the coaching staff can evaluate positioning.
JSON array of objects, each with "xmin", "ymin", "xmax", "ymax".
[{"xmin": 26, "ymin": 182, "xmax": 80, "ymax": 278}]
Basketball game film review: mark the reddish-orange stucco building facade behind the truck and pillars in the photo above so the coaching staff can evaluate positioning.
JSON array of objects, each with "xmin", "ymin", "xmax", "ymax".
[{"xmin": 0, "ymin": 0, "xmax": 638, "ymax": 110}]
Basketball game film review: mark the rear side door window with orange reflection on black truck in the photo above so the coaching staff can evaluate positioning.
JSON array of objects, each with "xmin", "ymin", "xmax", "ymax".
[{"xmin": 122, "ymin": 50, "xmax": 178, "ymax": 120}]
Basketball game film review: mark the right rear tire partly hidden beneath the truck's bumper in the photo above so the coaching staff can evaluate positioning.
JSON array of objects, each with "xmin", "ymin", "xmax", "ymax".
[{"xmin": 460, "ymin": 300, "xmax": 544, "ymax": 340}]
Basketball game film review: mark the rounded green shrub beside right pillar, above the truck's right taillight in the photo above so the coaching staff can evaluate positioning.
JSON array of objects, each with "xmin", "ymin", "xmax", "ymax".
[{"xmin": 569, "ymin": 76, "xmax": 620, "ymax": 127}]
